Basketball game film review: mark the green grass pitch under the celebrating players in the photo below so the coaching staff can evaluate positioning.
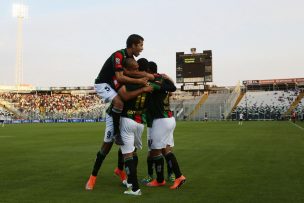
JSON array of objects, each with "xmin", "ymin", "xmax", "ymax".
[{"xmin": 0, "ymin": 122, "xmax": 304, "ymax": 203}]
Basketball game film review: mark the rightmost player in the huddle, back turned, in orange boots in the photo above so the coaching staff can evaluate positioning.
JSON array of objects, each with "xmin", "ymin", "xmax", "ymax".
[{"xmin": 147, "ymin": 62, "xmax": 186, "ymax": 189}]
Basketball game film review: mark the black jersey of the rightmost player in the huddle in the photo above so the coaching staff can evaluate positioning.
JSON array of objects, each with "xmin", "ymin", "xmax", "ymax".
[{"xmin": 148, "ymin": 75, "xmax": 176, "ymax": 120}]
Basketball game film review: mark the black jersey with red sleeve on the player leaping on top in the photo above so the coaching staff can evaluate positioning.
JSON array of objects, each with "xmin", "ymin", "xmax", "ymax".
[{"xmin": 95, "ymin": 49, "xmax": 134, "ymax": 89}]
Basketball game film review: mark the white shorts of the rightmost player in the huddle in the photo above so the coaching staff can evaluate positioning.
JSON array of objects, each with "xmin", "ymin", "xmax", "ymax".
[{"xmin": 147, "ymin": 117, "xmax": 176, "ymax": 151}]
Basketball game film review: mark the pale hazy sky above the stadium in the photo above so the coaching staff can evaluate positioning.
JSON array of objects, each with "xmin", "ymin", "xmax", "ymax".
[{"xmin": 0, "ymin": 0, "xmax": 304, "ymax": 87}]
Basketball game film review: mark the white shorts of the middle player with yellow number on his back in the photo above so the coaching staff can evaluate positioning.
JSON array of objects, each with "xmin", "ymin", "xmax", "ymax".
[{"xmin": 120, "ymin": 117, "xmax": 144, "ymax": 154}]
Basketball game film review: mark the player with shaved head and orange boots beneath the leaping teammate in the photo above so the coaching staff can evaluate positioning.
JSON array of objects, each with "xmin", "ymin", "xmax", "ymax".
[{"xmin": 86, "ymin": 59, "xmax": 152, "ymax": 190}]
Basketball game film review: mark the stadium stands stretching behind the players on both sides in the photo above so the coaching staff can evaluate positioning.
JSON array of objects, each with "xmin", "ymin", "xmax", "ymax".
[{"xmin": 0, "ymin": 78, "xmax": 304, "ymax": 122}]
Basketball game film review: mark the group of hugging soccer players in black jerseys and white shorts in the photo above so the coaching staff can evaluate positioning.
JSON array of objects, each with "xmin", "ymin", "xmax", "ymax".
[{"xmin": 86, "ymin": 34, "xmax": 186, "ymax": 195}]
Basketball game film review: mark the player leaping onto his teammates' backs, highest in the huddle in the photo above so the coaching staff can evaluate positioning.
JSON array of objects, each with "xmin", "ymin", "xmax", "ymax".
[{"xmin": 95, "ymin": 34, "xmax": 154, "ymax": 145}]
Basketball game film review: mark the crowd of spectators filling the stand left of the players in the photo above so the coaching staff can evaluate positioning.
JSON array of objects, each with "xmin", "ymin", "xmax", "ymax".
[{"xmin": 0, "ymin": 93, "xmax": 105, "ymax": 120}]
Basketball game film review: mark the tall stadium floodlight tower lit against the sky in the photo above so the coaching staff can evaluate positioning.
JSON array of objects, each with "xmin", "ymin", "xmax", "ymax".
[{"xmin": 13, "ymin": 3, "xmax": 28, "ymax": 86}]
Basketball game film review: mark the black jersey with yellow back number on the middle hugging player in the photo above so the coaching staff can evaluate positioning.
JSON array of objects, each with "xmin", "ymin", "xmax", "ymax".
[{"xmin": 121, "ymin": 84, "xmax": 147, "ymax": 123}]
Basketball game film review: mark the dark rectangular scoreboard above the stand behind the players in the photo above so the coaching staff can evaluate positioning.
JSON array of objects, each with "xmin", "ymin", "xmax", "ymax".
[{"xmin": 176, "ymin": 50, "xmax": 212, "ymax": 83}]
